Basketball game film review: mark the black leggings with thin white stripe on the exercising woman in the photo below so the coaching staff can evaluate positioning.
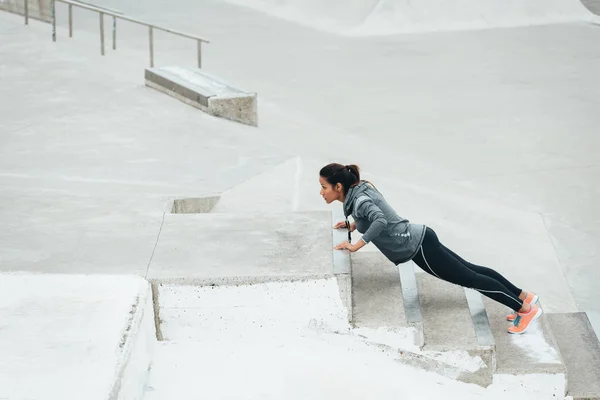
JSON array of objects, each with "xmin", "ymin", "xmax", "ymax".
[{"xmin": 413, "ymin": 227, "xmax": 523, "ymax": 311}]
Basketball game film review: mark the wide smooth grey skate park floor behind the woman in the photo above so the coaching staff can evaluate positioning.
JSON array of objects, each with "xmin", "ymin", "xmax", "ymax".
[{"xmin": 0, "ymin": 2, "xmax": 600, "ymax": 384}]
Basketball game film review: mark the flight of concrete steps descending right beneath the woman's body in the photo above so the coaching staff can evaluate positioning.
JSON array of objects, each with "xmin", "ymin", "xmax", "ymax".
[{"xmin": 351, "ymin": 252, "xmax": 600, "ymax": 399}]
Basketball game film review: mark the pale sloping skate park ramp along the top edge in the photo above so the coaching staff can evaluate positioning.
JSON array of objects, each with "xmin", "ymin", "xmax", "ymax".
[{"xmin": 217, "ymin": 0, "xmax": 592, "ymax": 36}]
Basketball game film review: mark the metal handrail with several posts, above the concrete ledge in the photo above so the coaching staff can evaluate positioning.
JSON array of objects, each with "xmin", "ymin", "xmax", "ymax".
[{"xmin": 25, "ymin": 0, "xmax": 210, "ymax": 68}]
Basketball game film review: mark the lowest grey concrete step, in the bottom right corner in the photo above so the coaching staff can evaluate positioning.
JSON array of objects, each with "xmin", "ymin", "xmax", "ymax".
[{"xmin": 547, "ymin": 312, "xmax": 600, "ymax": 400}]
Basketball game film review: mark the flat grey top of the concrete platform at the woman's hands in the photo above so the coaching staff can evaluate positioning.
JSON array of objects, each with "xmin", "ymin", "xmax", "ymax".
[{"xmin": 148, "ymin": 211, "xmax": 333, "ymax": 284}]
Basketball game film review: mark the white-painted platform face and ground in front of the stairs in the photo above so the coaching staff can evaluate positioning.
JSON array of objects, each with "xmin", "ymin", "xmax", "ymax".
[{"xmin": 146, "ymin": 280, "xmax": 564, "ymax": 400}]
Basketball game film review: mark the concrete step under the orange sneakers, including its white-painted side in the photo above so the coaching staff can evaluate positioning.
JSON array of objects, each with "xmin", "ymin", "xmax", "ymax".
[{"xmin": 484, "ymin": 297, "xmax": 566, "ymax": 397}]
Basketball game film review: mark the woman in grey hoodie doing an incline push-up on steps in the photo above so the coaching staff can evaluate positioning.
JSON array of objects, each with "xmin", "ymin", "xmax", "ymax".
[{"xmin": 319, "ymin": 163, "xmax": 542, "ymax": 334}]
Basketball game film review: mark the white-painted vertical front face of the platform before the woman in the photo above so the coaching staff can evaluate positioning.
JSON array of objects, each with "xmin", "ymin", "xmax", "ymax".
[{"xmin": 159, "ymin": 278, "xmax": 350, "ymax": 341}]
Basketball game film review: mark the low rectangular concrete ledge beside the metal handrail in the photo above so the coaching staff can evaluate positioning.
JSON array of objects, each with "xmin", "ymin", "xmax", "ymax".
[{"xmin": 145, "ymin": 66, "xmax": 258, "ymax": 126}]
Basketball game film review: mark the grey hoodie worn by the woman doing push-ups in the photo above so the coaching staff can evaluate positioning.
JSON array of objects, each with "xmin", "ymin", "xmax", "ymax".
[{"xmin": 343, "ymin": 181, "xmax": 425, "ymax": 265}]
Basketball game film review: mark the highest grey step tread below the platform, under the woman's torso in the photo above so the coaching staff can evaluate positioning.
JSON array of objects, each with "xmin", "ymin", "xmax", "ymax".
[{"xmin": 352, "ymin": 252, "xmax": 407, "ymax": 328}]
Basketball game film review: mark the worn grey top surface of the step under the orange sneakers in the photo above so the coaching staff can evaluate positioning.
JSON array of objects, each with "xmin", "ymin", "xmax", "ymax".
[{"xmin": 484, "ymin": 297, "xmax": 565, "ymax": 375}]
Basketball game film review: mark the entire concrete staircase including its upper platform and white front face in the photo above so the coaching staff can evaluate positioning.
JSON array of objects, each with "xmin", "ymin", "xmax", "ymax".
[{"xmin": 137, "ymin": 209, "xmax": 600, "ymax": 399}]
